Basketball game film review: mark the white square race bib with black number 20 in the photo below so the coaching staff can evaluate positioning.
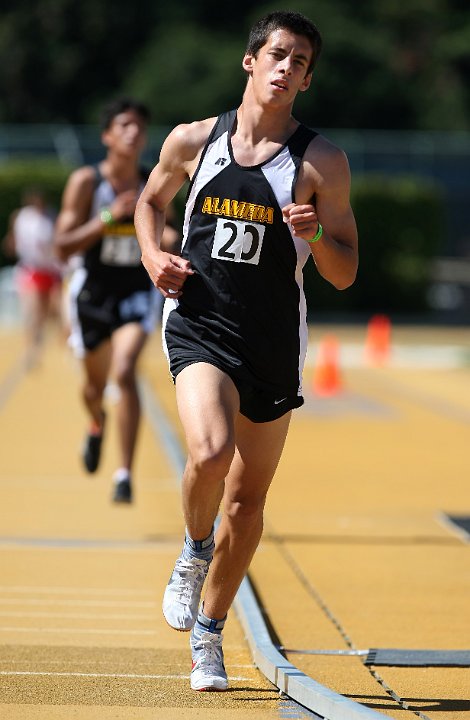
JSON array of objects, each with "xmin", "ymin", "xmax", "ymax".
[{"xmin": 211, "ymin": 218, "xmax": 266, "ymax": 265}]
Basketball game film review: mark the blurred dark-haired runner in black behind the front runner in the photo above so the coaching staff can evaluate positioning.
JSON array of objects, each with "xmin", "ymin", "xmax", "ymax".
[{"xmin": 55, "ymin": 98, "xmax": 176, "ymax": 503}]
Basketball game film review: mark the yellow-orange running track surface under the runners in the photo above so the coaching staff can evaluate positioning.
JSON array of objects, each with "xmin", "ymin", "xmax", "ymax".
[{"xmin": 0, "ymin": 328, "xmax": 470, "ymax": 720}]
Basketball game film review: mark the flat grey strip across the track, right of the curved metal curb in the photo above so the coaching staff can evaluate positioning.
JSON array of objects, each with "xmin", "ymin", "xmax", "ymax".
[{"xmin": 364, "ymin": 648, "xmax": 470, "ymax": 667}]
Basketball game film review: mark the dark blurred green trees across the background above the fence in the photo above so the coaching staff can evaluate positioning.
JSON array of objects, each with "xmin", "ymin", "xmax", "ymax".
[{"xmin": 0, "ymin": 0, "xmax": 470, "ymax": 130}]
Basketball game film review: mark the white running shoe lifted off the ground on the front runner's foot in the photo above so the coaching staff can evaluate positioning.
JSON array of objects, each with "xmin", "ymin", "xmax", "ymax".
[{"xmin": 163, "ymin": 555, "xmax": 210, "ymax": 631}]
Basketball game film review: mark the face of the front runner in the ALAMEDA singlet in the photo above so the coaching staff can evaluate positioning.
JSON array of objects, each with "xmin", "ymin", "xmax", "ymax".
[{"xmin": 243, "ymin": 29, "xmax": 313, "ymax": 104}]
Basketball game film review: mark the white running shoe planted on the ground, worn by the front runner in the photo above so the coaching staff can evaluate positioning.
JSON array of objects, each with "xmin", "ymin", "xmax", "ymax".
[{"xmin": 190, "ymin": 626, "xmax": 228, "ymax": 692}]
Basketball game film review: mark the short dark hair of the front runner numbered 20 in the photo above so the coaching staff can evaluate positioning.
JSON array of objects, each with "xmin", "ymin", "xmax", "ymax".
[{"xmin": 246, "ymin": 10, "xmax": 323, "ymax": 74}]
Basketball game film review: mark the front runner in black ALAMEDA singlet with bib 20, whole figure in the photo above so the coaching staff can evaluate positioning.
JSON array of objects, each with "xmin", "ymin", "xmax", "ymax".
[{"xmin": 135, "ymin": 12, "xmax": 358, "ymax": 690}]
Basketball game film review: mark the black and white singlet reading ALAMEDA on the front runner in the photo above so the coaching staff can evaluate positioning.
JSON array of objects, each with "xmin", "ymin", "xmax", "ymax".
[{"xmin": 163, "ymin": 110, "xmax": 317, "ymax": 407}]
